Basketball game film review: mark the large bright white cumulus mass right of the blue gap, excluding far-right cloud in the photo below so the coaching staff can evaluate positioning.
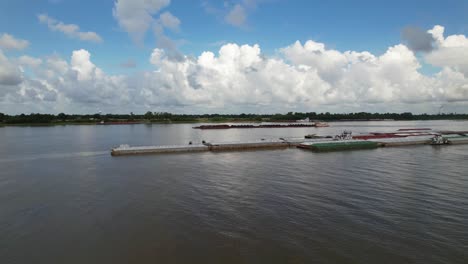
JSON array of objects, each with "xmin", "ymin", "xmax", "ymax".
[{"xmin": 142, "ymin": 41, "xmax": 433, "ymax": 108}]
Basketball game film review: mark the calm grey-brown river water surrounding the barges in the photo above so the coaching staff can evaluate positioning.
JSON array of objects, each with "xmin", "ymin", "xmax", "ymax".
[{"xmin": 0, "ymin": 121, "xmax": 468, "ymax": 263}]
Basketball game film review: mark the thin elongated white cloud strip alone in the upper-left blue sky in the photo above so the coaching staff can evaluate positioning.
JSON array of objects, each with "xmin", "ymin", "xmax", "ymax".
[{"xmin": 37, "ymin": 14, "xmax": 102, "ymax": 43}]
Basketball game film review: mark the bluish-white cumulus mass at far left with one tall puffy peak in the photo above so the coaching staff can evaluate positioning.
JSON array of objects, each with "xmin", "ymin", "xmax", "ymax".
[{"xmin": 0, "ymin": 49, "xmax": 132, "ymax": 112}]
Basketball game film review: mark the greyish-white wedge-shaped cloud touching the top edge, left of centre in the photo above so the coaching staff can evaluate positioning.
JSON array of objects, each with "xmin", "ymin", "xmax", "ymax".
[{"xmin": 112, "ymin": 0, "xmax": 171, "ymax": 44}]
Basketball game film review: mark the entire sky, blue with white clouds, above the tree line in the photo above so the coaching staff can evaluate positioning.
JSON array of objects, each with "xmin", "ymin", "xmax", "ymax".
[{"xmin": 0, "ymin": 0, "xmax": 468, "ymax": 114}]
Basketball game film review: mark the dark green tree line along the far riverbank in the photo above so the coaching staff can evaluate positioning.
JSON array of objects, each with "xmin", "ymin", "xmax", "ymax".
[{"xmin": 0, "ymin": 111, "xmax": 468, "ymax": 124}]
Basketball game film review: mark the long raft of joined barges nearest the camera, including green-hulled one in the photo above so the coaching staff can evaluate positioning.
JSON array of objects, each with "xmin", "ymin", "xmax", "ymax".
[{"xmin": 111, "ymin": 130, "xmax": 468, "ymax": 156}]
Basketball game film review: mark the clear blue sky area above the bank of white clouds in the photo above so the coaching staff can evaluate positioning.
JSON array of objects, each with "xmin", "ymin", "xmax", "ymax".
[{"xmin": 0, "ymin": 0, "xmax": 468, "ymax": 111}]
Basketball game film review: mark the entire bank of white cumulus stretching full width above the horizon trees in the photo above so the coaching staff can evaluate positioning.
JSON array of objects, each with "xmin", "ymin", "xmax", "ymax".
[{"xmin": 0, "ymin": 27, "xmax": 468, "ymax": 112}]
